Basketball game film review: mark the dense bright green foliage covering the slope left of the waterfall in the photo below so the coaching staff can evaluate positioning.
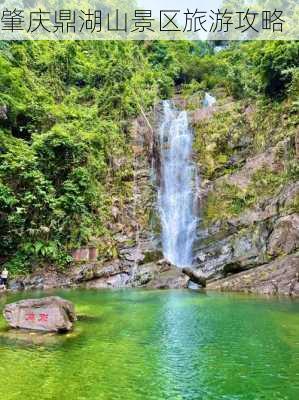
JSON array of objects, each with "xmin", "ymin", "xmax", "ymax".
[{"xmin": 0, "ymin": 41, "xmax": 180, "ymax": 273}]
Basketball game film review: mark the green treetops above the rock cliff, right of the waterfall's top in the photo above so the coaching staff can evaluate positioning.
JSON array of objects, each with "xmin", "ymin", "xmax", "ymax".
[{"xmin": 185, "ymin": 41, "xmax": 299, "ymax": 99}]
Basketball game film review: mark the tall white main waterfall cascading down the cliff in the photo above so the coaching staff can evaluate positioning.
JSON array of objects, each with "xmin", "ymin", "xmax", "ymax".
[{"xmin": 158, "ymin": 101, "xmax": 198, "ymax": 267}]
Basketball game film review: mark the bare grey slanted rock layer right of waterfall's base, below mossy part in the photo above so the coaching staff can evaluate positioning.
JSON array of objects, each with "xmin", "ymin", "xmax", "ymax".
[{"xmin": 194, "ymin": 183, "xmax": 299, "ymax": 280}]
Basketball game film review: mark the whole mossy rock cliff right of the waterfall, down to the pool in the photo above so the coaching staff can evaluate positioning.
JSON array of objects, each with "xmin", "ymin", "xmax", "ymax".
[{"xmin": 192, "ymin": 93, "xmax": 299, "ymax": 296}]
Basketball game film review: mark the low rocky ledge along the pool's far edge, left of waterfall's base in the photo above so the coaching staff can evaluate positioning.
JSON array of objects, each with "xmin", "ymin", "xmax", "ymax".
[{"xmin": 6, "ymin": 259, "xmax": 189, "ymax": 290}]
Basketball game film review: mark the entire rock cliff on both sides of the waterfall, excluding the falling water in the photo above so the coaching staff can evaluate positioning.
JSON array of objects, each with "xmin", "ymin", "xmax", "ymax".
[{"xmin": 4, "ymin": 98, "xmax": 299, "ymax": 296}]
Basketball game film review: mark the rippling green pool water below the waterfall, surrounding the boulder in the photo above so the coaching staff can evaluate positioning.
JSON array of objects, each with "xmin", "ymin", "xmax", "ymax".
[{"xmin": 0, "ymin": 290, "xmax": 299, "ymax": 400}]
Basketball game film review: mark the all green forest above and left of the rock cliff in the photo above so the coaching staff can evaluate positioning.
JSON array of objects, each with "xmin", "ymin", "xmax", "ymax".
[{"xmin": 0, "ymin": 41, "xmax": 299, "ymax": 273}]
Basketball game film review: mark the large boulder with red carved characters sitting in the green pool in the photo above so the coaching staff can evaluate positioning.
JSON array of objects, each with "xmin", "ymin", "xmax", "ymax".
[{"xmin": 3, "ymin": 296, "xmax": 76, "ymax": 332}]
